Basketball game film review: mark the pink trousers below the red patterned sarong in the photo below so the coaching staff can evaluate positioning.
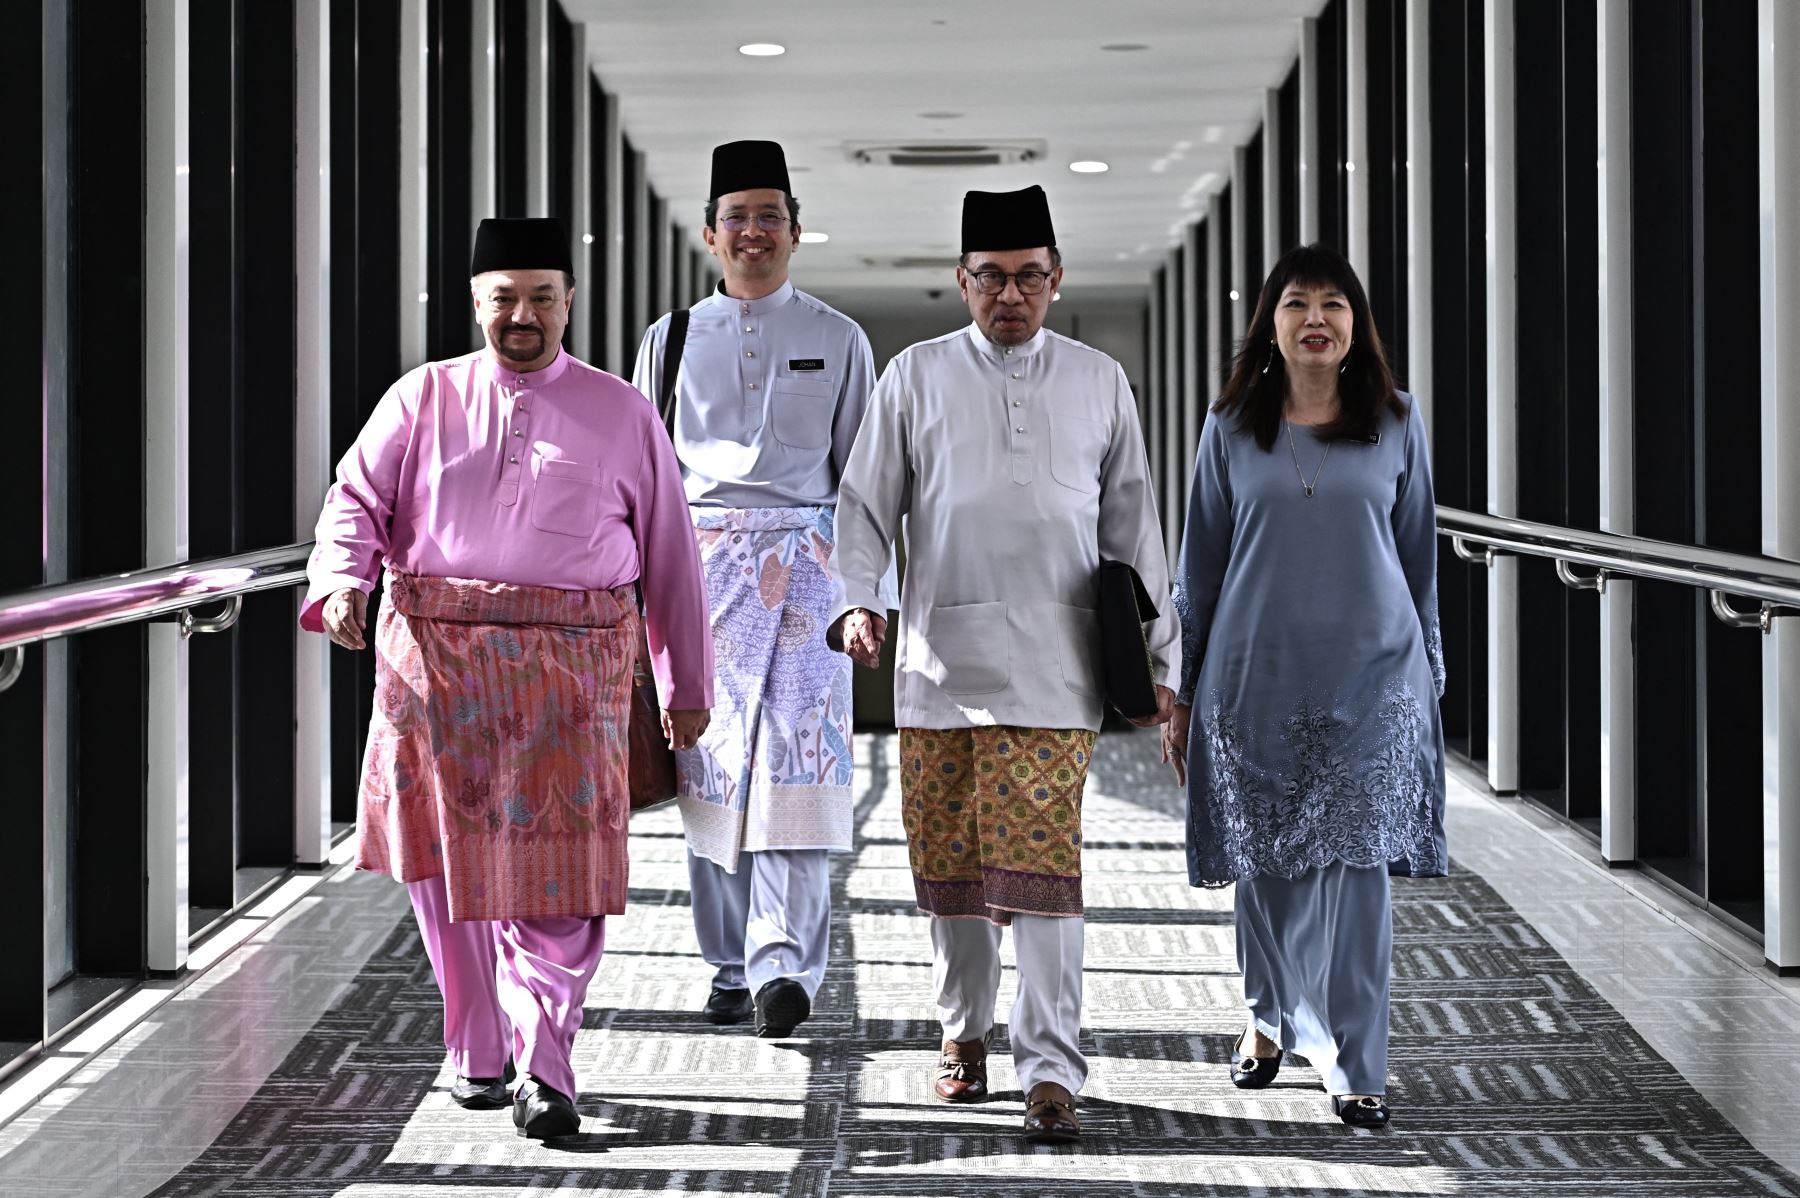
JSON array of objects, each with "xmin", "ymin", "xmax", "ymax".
[{"xmin": 407, "ymin": 878, "xmax": 607, "ymax": 1099}]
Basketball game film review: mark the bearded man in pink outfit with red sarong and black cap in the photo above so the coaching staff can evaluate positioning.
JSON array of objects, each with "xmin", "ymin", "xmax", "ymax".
[{"xmin": 301, "ymin": 219, "xmax": 713, "ymax": 1139}]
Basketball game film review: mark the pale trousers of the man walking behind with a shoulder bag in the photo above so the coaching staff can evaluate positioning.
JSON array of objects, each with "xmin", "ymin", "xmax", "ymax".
[{"xmin": 688, "ymin": 849, "xmax": 832, "ymax": 998}]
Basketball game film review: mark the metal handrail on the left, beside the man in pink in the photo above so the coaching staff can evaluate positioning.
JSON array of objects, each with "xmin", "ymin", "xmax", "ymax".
[{"xmin": 0, "ymin": 541, "xmax": 313, "ymax": 649}]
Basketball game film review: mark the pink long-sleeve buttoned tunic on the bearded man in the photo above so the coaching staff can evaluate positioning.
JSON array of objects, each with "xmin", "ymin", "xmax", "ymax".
[{"xmin": 301, "ymin": 351, "xmax": 713, "ymax": 711}]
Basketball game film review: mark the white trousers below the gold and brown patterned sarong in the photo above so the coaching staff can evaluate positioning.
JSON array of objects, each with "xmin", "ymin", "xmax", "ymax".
[{"xmin": 931, "ymin": 914, "xmax": 1087, "ymax": 1094}]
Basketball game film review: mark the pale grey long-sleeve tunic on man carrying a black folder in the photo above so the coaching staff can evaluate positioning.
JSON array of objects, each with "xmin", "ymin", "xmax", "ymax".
[{"xmin": 833, "ymin": 326, "xmax": 1181, "ymax": 730}]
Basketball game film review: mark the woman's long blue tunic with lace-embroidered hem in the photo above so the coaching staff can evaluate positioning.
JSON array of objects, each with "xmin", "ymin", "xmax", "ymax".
[{"xmin": 1175, "ymin": 392, "xmax": 1449, "ymax": 887}]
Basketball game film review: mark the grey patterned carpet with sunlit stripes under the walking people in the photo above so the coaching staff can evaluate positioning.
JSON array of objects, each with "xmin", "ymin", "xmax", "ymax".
[{"xmin": 140, "ymin": 734, "xmax": 1800, "ymax": 1198}]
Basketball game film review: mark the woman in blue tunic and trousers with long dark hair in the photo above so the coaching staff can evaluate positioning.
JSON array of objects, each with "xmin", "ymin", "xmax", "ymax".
[{"xmin": 1165, "ymin": 246, "xmax": 1447, "ymax": 1126}]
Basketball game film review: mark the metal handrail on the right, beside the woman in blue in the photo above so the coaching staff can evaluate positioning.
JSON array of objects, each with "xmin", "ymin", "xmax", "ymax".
[{"xmin": 1438, "ymin": 505, "xmax": 1800, "ymax": 631}]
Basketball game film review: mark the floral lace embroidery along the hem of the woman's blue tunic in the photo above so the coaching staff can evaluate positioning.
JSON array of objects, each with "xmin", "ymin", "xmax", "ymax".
[{"xmin": 1188, "ymin": 678, "xmax": 1444, "ymax": 887}]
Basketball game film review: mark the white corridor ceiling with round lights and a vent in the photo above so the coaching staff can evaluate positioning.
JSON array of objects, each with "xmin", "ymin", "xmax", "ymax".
[{"xmin": 563, "ymin": 0, "xmax": 1323, "ymax": 293}]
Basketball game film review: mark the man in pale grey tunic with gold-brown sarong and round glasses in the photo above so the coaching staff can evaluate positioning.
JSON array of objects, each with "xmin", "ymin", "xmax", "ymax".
[{"xmin": 833, "ymin": 187, "xmax": 1181, "ymax": 1140}]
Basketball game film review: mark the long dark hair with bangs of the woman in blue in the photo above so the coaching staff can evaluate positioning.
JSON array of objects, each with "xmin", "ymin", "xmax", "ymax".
[{"xmin": 1213, "ymin": 241, "xmax": 1406, "ymax": 450}]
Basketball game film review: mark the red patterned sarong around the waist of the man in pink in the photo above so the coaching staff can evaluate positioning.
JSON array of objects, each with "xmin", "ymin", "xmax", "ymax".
[{"xmin": 356, "ymin": 570, "xmax": 637, "ymax": 919}]
